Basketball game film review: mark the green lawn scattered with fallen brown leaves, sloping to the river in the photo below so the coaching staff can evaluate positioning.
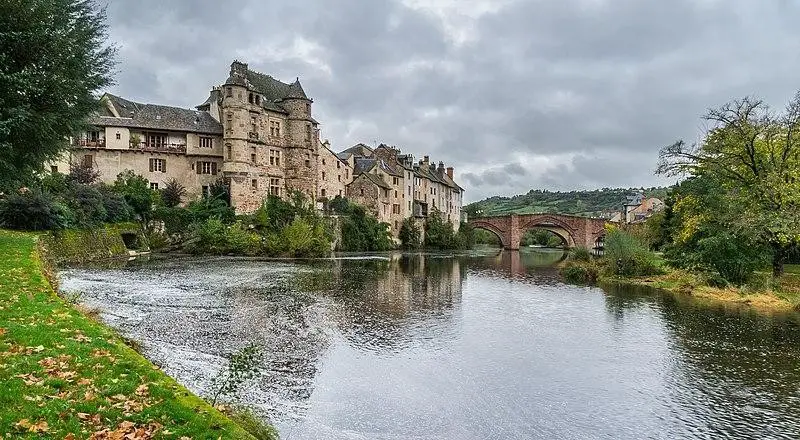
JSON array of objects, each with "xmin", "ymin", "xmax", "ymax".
[{"xmin": 0, "ymin": 231, "xmax": 260, "ymax": 440}]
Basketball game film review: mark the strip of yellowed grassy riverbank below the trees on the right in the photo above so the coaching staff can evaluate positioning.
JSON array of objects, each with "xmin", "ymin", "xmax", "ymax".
[{"xmin": 598, "ymin": 268, "xmax": 800, "ymax": 313}]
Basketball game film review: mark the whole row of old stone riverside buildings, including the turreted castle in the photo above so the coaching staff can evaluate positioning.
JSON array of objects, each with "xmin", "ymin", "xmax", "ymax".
[{"xmin": 61, "ymin": 61, "xmax": 463, "ymax": 234}]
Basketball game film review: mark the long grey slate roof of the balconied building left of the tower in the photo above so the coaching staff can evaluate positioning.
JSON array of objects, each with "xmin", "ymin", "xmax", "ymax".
[{"xmin": 88, "ymin": 93, "xmax": 222, "ymax": 135}]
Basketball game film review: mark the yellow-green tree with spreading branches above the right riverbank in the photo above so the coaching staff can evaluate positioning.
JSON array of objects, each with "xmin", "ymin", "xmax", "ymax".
[{"xmin": 657, "ymin": 93, "xmax": 800, "ymax": 277}]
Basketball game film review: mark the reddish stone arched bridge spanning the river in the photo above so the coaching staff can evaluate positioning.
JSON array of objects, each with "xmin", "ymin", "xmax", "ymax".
[{"xmin": 468, "ymin": 214, "xmax": 606, "ymax": 250}]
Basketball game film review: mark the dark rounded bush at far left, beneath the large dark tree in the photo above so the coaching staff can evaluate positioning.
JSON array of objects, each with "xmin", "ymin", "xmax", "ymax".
[{"xmin": 0, "ymin": 190, "xmax": 73, "ymax": 231}]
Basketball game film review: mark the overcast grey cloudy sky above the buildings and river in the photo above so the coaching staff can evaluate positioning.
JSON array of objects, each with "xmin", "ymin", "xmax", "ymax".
[{"xmin": 107, "ymin": 0, "xmax": 800, "ymax": 201}]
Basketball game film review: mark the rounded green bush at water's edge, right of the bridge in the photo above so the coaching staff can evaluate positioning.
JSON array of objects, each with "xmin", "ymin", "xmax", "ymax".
[{"xmin": 604, "ymin": 228, "xmax": 661, "ymax": 277}]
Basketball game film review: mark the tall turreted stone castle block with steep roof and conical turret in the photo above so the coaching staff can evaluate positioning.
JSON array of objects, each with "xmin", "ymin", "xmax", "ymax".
[{"xmin": 216, "ymin": 61, "xmax": 319, "ymax": 213}]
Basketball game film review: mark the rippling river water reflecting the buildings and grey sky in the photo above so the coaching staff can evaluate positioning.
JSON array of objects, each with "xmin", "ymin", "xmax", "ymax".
[{"xmin": 61, "ymin": 251, "xmax": 800, "ymax": 440}]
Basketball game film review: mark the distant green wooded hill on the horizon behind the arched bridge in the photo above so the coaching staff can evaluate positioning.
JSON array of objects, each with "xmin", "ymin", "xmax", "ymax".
[{"xmin": 464, "ymin": 187, "xmax": 669, "ymax": 217}]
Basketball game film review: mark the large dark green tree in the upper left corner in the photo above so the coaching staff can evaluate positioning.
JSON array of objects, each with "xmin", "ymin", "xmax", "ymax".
[{"xmin": 0, "ymin": 0, "xmax": 116, "ymax": 188}]
